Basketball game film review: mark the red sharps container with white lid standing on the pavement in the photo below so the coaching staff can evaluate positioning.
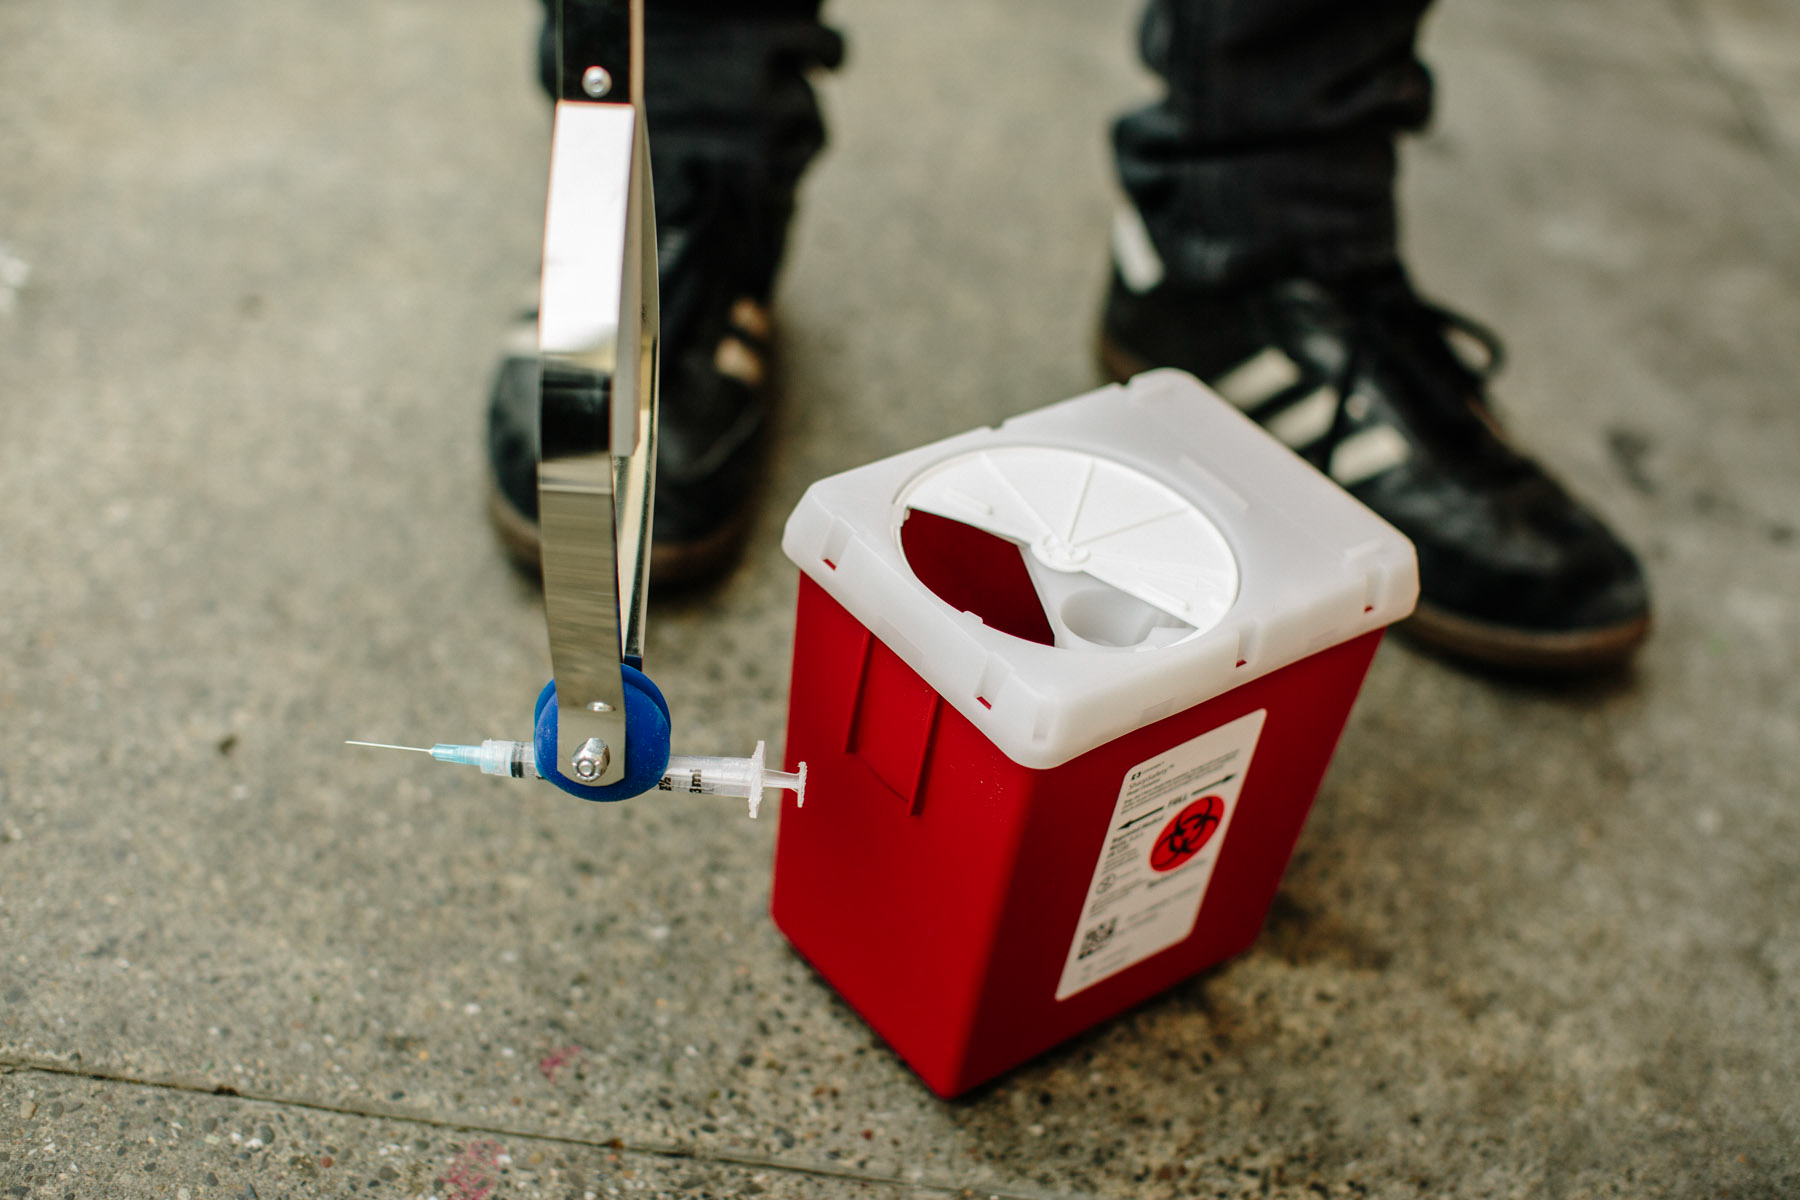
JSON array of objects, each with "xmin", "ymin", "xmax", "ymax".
[{"xmin": 772, "ymin": 371, "xmax": 1418, "ymax": 1096}]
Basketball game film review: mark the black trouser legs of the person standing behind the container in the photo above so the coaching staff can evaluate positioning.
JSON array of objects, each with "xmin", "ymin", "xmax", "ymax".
[{"xmin": 542, "ymin": 0, "xmax": 1431, "ymax": 286}]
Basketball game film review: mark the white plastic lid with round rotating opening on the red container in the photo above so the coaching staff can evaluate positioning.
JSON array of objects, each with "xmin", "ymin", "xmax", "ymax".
[{"xmin": 781, "ymin": 371, "xmax": 1418, "ymax": 768}]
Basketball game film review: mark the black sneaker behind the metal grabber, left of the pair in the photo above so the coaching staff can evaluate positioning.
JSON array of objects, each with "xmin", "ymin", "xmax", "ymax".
[{"xmin": 488, "ymin": 167, "xmax": 788, "ymax": 585}]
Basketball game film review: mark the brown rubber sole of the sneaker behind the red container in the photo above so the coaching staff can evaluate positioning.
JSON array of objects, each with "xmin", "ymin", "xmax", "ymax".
[{"xmin": 1100, "ymin": 333, "xmax": 1651, "ymax": 673}]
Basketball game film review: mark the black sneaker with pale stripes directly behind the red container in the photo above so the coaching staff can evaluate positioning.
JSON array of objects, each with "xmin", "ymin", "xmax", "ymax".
[{"xmin": 1100, "ymin": 266, "xmax": 1651, "ymax": 669}]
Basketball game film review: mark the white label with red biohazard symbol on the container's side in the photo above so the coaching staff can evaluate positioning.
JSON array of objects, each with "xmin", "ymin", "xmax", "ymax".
[{"xmin": 1057, "ymin": 709, "xmax": 1267, "ymax": 1000}]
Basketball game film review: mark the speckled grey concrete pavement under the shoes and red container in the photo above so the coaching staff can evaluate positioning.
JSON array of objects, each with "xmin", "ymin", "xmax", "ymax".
[{"xmin": 0, "ymin": 0, "xmax": 1800, "ymax": 1200}]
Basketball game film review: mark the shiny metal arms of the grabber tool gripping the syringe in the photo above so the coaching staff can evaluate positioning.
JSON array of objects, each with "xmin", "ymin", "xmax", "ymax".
[{"xmin": 538, "ymin": 0, "xmax": 668, "ymax": 786}]
